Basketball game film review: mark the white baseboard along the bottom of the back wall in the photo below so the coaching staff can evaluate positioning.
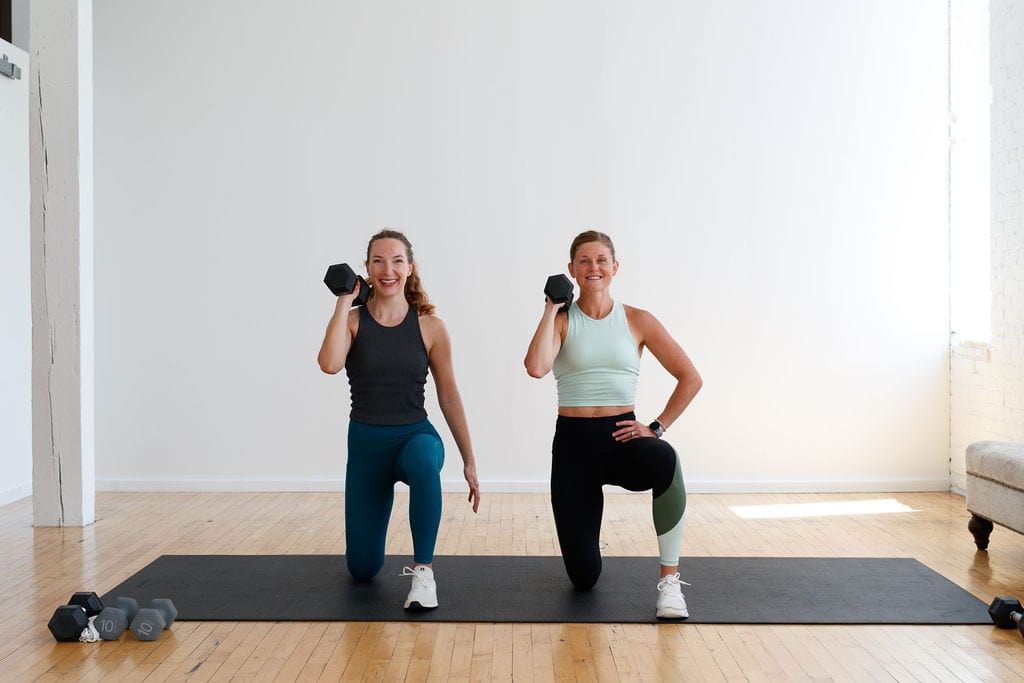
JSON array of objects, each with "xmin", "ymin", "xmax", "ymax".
[{"xmin": 96, "ymin": 478, "xmax": 950, "ymax": 494}]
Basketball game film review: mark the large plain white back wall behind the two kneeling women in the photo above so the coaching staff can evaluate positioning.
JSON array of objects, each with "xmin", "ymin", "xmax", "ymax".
[{"xmin": 95, "ymin": 0, "xmax": 949, "ymax": 490}]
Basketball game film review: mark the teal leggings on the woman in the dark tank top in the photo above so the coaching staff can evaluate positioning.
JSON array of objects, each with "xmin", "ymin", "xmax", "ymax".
[{"xmin": 345, "ymin": 420, "xmax": 444, "ymax": 579}]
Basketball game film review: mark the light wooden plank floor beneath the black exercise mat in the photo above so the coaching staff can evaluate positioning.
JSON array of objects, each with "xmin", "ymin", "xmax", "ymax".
[{"xmin": 0, "ymin": 493, "xmax": 1024, "ymax": 681}]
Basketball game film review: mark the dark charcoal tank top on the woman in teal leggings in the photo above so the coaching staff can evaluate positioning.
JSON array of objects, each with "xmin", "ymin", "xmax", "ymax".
[{"xmin": 345, "ymin": 306, "xmax": 429, "ymax": 425}]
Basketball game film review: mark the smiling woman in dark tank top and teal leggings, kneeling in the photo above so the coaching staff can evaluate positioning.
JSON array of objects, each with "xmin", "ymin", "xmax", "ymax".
[{"xmin": 317, "ymin": 230, "xmax": 480, "ymax": 610}]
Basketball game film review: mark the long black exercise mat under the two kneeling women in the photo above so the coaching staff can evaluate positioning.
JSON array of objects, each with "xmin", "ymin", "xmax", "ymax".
[{"xmin": 102, "ymin": 555, "xmax": 991, "ymax": 624}]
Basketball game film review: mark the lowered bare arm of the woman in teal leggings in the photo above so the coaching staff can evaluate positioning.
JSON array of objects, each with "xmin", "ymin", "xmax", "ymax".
[{"xmin": 420, "ymin": 315, "xmax": 480, "ymax": 512}]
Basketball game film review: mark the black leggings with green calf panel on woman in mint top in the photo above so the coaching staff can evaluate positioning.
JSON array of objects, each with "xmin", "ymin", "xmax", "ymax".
[{"xmin": 551, "ymin": 413, "xmax": 686, "ymax": 590}]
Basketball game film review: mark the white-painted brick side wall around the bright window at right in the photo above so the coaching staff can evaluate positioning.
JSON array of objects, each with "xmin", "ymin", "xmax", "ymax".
[{"xmin": 950, "ymin": 0, "xmax": 1024, "ymax": 490}]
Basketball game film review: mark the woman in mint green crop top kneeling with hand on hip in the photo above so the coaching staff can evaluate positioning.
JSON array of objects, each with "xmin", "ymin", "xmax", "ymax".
[{"xmin": 525, "ymin": 230, "xmax": 702, "ymax": 618}]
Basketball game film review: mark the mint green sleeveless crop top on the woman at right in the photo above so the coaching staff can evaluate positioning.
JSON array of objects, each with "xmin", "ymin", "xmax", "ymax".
[{"xmin": 552, "ymin": 301, "xmax": 640, "ymax": 407}]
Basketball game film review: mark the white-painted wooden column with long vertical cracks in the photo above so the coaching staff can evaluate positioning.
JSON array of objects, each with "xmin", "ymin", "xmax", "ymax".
[{"xmin": 30, "ymin": 0, "xmax": 96, "ymax": 526}]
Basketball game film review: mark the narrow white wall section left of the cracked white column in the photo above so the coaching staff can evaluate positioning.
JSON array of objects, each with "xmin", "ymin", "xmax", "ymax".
[{"xmin": 0, "ymin": 40, "xmax": 32, "ymax": 505}]
